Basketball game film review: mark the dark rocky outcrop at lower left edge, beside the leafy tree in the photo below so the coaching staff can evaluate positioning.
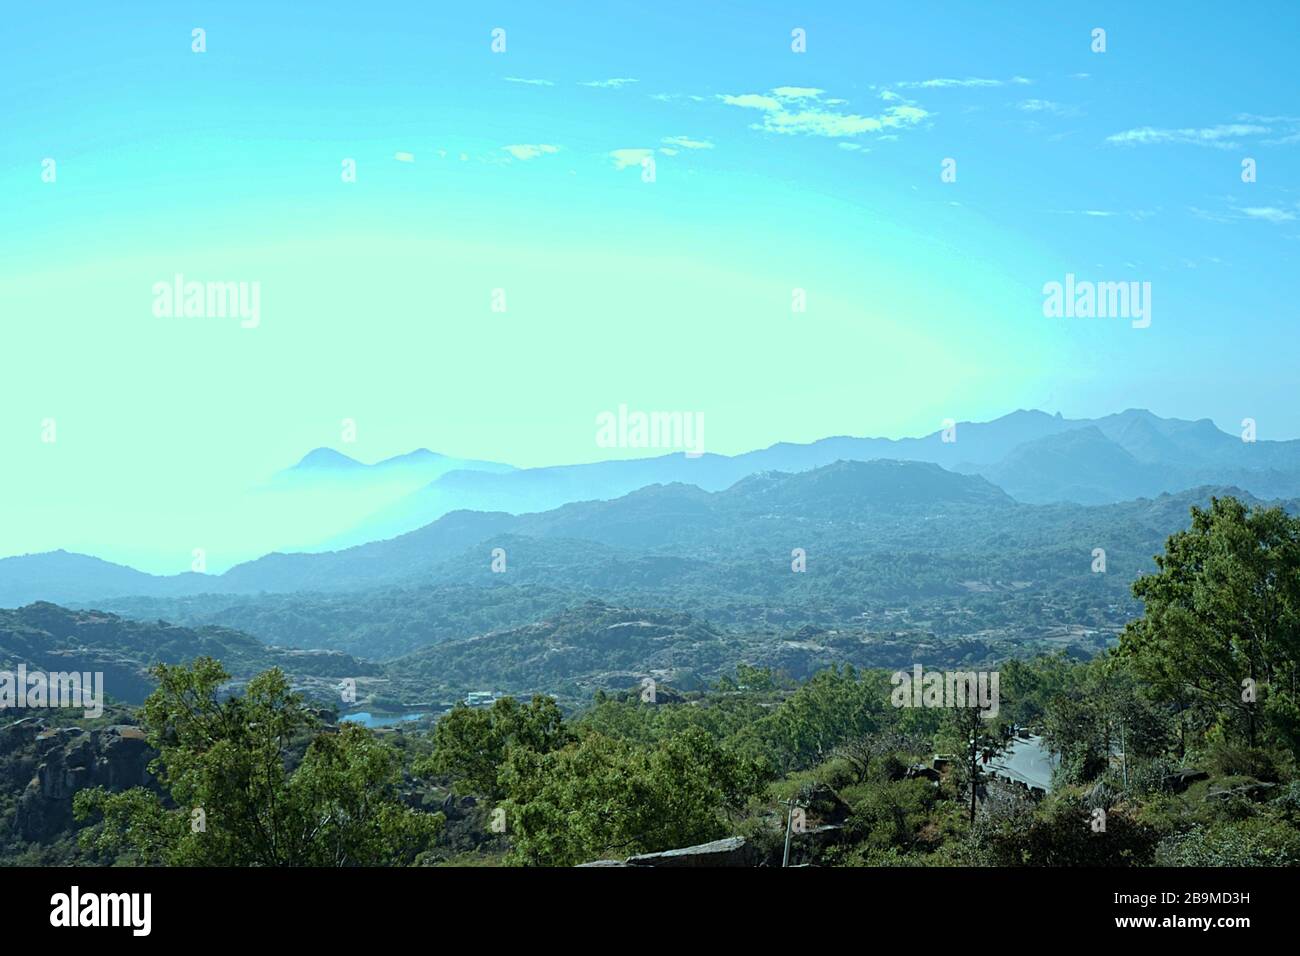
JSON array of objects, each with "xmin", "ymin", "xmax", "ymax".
[{"xmin": 0, "ymin": 718, "xmax": 156, "ymax": 842}]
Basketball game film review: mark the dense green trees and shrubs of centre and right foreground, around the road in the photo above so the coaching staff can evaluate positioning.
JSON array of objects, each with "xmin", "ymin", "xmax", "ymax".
[{"xmin": 403, "ymin": 499, "xmax": 1300, "ymax": 866}]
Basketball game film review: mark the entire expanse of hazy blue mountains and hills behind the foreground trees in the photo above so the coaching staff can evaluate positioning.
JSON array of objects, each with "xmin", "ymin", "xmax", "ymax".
[{"xmin": 0, "ymin": 411, "xmax": 1300, "ymax": 701}]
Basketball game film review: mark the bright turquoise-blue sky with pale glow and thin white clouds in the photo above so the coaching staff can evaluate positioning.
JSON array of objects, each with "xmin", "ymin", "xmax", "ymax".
[{"xmin": 0, "ymin": 0, "xmax": 1300, "ymax": 567}]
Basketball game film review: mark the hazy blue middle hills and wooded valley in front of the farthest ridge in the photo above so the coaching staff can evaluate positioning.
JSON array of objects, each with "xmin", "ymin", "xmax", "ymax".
[{"xmin": 0, "ymin": 459, "xmax": 1297, "ymax": 686}]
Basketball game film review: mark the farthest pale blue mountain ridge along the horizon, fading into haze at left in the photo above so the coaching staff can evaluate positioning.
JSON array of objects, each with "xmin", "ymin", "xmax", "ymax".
[{"xmin": 0, "ymin": 408, "xmax": 1300, "ymax": 605}]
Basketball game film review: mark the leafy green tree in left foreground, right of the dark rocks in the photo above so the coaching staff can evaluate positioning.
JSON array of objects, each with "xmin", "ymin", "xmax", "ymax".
[{"xmin": 74, "ymin": 658, "xmax": 442, "ymax": 866}]
